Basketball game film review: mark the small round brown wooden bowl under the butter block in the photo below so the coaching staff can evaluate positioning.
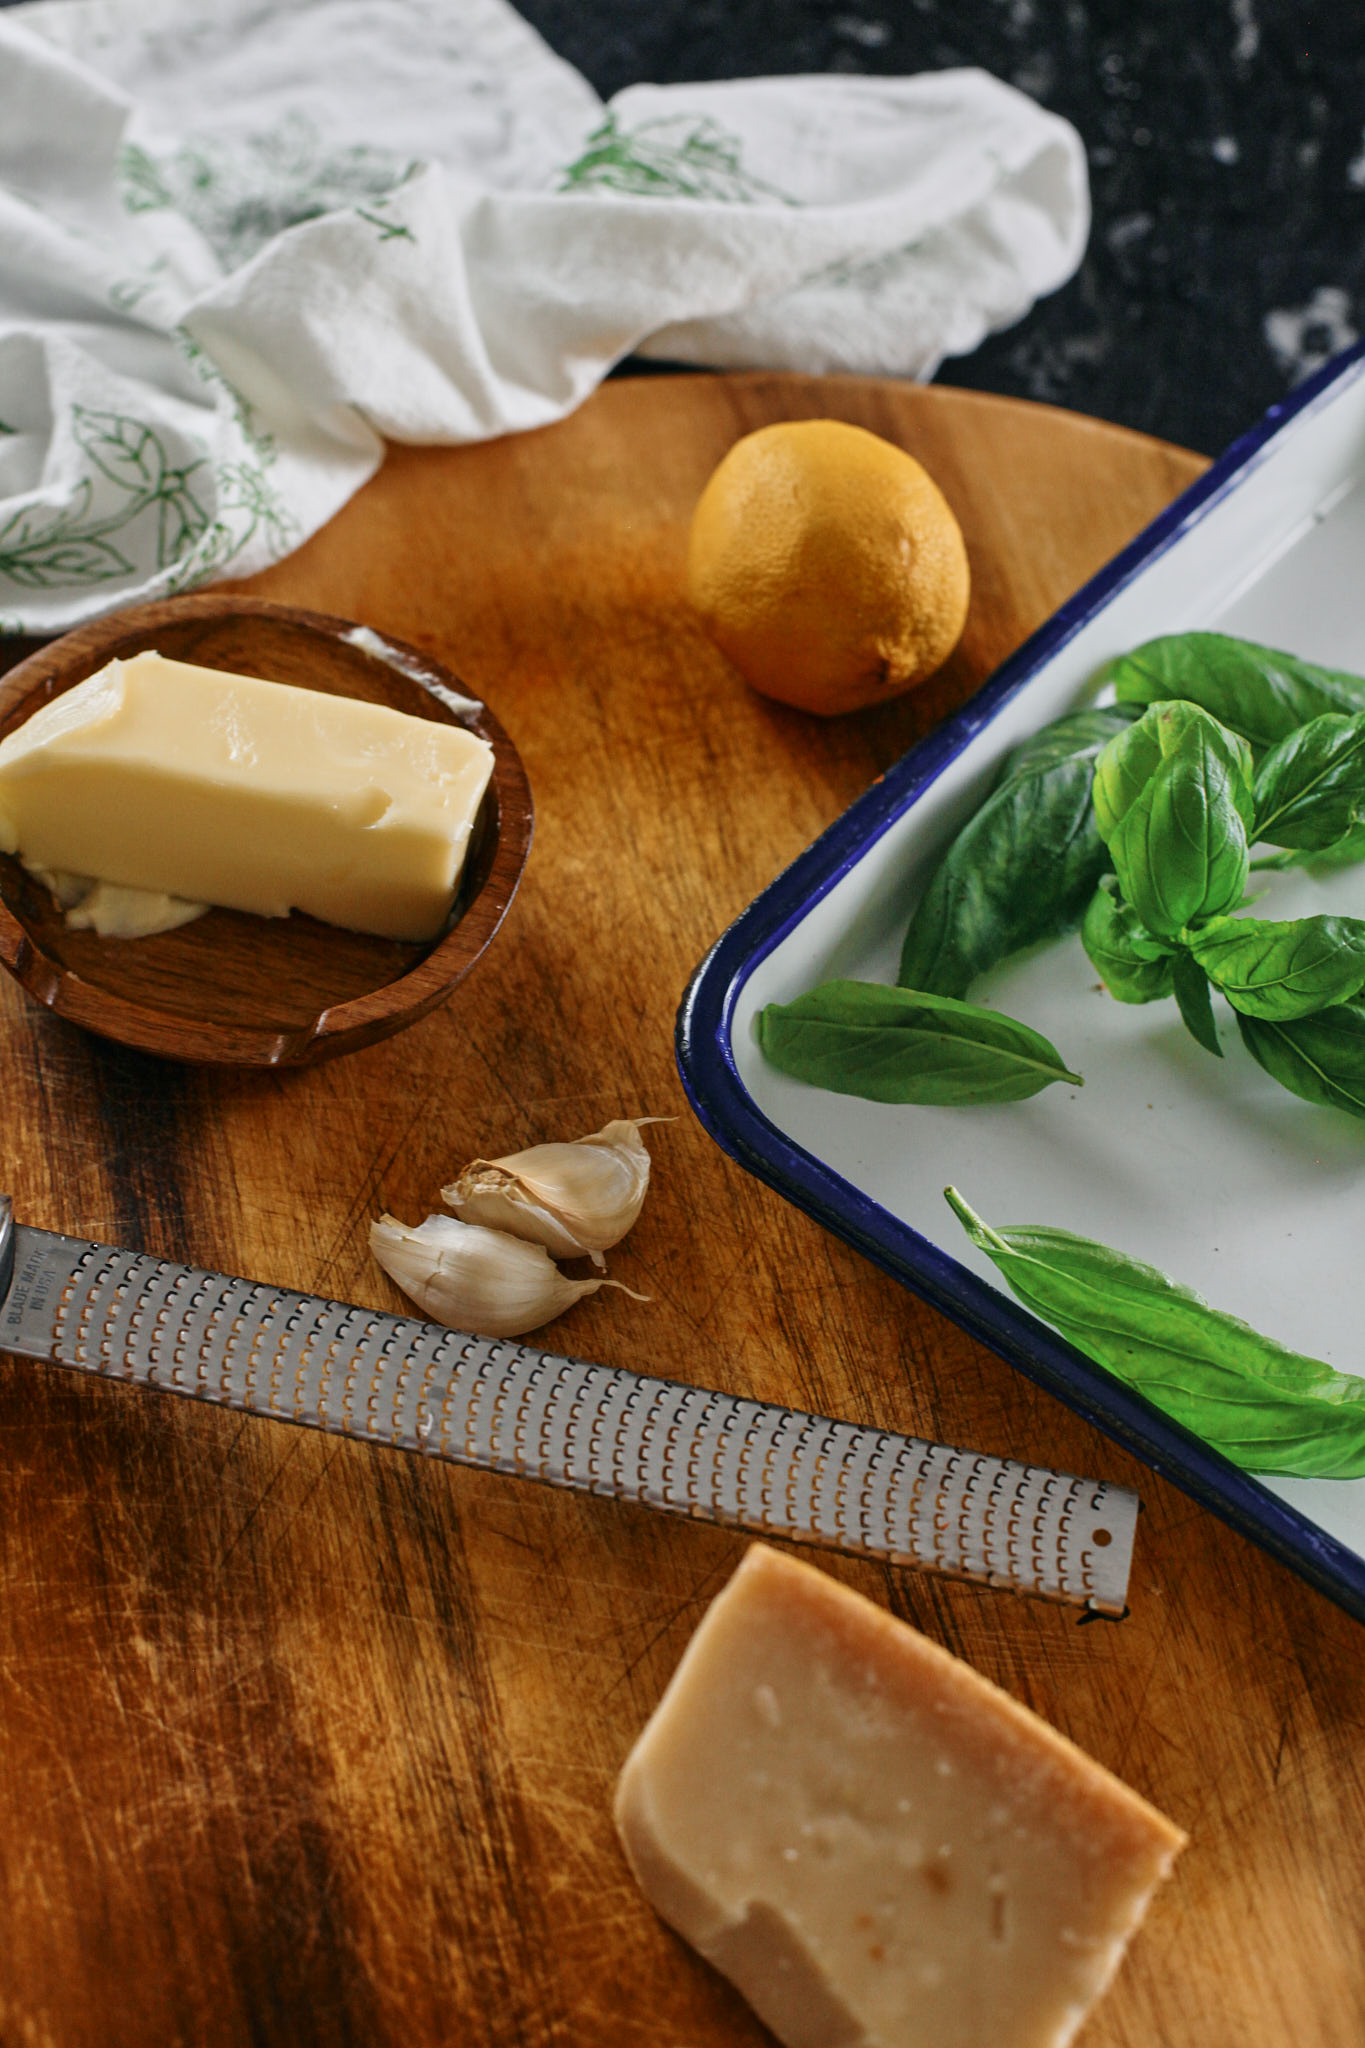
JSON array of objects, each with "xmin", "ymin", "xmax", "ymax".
[{"xmin": 0, "ymin": 596, "xmax": 532, "ymax": 1067}]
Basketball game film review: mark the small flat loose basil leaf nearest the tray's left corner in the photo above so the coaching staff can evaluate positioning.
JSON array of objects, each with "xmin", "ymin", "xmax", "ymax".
[{"xmin": 757, "ymin": 981, "xmax": 1083, "ymax": 1108}]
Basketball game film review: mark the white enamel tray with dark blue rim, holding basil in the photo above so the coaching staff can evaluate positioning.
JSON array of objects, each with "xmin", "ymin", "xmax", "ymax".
[{"xmin": 677, "ymin": 346, "xmax": 1365, "ymax": 1620}]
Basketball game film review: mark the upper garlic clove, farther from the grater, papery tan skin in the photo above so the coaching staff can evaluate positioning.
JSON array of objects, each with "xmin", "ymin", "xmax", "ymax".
[{"xmin": 440, "ymin": 1116, "xmax": 673, "ymax": 1266}]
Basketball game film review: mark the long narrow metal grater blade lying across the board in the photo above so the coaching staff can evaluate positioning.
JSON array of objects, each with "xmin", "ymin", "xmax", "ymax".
[{"xmin": 0, "ymin": 1196, "xmax": 1140, "ymax": 1614}]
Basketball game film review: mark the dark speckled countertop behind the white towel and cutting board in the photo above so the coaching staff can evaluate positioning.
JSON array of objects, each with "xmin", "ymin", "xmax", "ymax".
[{"xmin": 520, "ymin": 0, "xmax": 1365, "ymax": 455}]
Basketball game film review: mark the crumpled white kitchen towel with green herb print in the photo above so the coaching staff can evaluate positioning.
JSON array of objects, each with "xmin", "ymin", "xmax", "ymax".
[{"xmin": 0, "ymin": 0, "xmax": 1089, "ymax": 633}]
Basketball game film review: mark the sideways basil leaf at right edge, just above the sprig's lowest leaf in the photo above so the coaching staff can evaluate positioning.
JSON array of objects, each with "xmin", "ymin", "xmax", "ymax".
[{"xmin": 1187, "ymin": 918, "xmax": 1365, "ymax": 1024}]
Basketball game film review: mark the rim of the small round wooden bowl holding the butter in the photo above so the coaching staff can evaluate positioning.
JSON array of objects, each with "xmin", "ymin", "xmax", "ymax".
[{"xmin": 0, "ymin": 592, "xmax": 534, "ymax": 1067}]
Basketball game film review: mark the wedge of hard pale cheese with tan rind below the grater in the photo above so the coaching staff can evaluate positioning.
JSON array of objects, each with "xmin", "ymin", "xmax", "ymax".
[{"xmin": 616, "ymin": 1544, "xmax": 1185, "ymax": 2048}]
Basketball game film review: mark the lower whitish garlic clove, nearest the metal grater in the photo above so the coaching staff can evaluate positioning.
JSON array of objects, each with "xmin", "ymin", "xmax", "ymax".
[{"xmin": 370, "ymin": 1214, "xmax": 649, "ymax": 1337}]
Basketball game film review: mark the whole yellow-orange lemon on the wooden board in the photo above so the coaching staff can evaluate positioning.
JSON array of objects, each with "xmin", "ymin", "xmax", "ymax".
[{"xmin": 688, "ymin": 420, "xmax": 970, "ymax": 717}]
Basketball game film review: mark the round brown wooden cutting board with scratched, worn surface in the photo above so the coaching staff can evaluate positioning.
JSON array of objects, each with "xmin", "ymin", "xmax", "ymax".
[{"xmin": 0, "ymin": 375, "xmax": 1365, "ymax": 2048}]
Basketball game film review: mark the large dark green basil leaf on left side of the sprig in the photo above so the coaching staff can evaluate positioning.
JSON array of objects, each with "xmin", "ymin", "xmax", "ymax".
[{"xmin": 898, "ymin": 707, "xmax": 1136, "ymax": 995}]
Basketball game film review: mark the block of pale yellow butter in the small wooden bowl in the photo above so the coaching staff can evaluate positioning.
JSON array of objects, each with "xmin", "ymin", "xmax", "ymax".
[{"xmin": 0, "ymin": 653, "xmax": 493, "ymax": 940}]
